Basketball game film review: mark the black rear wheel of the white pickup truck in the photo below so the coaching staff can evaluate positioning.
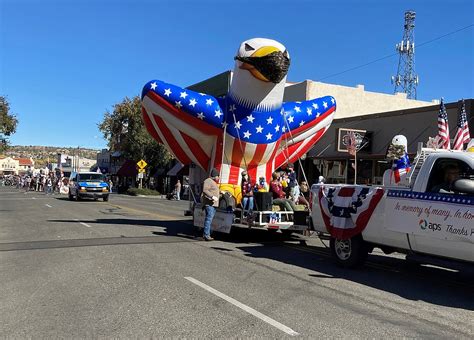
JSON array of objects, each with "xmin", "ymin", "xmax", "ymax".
[{"xmin": 330, "ymin": 235, "xmax": 369, "ymax": 268}]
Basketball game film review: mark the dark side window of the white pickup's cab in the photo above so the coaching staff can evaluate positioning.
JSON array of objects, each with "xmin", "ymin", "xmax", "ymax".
[{"xmin": 426, "ymin": 158, "xmax": 474, "ymax": 194}]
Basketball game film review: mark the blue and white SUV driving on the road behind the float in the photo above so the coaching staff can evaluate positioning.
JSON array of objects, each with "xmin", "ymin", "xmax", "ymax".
[{"xmin": 69, "ymin": 172, "xmax": 110, "ymax": 202}]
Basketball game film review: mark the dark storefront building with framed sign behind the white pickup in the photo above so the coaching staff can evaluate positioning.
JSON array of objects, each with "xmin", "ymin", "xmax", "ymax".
[{"xmin": 304, "ymin": 99, "xmax": 474, "ymax": 184}]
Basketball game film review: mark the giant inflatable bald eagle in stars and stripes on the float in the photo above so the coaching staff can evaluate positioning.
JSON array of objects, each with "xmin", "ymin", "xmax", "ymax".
[{"xmin": 142, "ymin": 38, "xmax": 336, "ymax": 190}]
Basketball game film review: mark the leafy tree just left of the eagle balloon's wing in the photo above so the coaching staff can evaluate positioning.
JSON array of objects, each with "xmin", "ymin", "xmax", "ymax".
[{"xmin": 99, "ymin": 96, "xmax": 172, "ymax": 172}]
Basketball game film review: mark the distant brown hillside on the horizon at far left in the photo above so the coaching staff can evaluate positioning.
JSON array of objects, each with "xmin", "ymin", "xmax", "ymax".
[{"xmin": 5, "ymin": 145, "xmax": 100, "ymax": 165}]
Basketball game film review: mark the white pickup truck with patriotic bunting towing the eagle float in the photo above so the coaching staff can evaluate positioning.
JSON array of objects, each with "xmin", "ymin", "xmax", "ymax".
[{"xmin": 309, "ymin": 149, "xmax": 474, "ymax": 267}]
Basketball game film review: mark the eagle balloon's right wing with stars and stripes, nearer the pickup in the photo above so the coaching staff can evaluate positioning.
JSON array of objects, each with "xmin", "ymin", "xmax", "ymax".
[{"xmin": 275, "ymin": 96, "xmax": 336, "ymax": 168}]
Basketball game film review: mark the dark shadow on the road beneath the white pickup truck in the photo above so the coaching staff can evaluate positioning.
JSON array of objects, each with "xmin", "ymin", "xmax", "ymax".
[{"xmin": 239, "ymin": 246, "xmax": 474, "ymax": 310}]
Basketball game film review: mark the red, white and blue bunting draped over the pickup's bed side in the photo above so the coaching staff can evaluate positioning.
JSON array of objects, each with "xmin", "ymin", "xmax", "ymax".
[{"xmin": 319, "ymin": 185, "xmax": 384, "ymax": 240}]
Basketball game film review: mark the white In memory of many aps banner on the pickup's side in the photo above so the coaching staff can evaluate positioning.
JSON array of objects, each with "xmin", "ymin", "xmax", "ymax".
[{"xmin": 385, "ymin": 190, "xmax": 474, "ymax": 243}]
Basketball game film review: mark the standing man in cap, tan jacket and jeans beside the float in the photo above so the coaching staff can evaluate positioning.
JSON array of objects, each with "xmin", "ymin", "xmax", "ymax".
[{"xmin": 201, "ymin": 168, "xmax": 219, "ymax": 241}]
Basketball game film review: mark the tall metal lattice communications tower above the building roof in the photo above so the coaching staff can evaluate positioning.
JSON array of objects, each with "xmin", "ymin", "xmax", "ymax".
[{"xmin": 392, "ymin": 11, "xmax": 419, "ymax": 99}]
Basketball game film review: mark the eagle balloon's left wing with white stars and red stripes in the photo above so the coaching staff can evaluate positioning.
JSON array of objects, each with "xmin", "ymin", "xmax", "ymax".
[{"xmin": 142, "ymin": 80, "xmax": 224, "ymax": 170}]
